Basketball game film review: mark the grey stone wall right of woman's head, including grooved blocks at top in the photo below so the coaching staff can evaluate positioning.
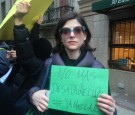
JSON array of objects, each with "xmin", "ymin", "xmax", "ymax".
[{"xmin": 78, "ymin": 0, "xmax": 109, "ymax": 67}]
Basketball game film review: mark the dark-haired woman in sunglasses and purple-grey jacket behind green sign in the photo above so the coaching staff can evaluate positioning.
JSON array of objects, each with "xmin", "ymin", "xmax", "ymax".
[{"xmin": 30, "ymin": 12, "xmax": 115, "ymax": 115}]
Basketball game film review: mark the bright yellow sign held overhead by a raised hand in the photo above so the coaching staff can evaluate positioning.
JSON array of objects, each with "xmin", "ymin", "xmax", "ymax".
[{"xmin": 0, "ymin": 0, "xmax": 53, "ymax": 40}]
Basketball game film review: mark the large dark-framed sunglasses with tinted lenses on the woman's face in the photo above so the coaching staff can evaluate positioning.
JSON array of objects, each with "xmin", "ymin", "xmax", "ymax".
[{"xmin": 59, "ymin": 26, "xmax": 86, "ymax": 36}]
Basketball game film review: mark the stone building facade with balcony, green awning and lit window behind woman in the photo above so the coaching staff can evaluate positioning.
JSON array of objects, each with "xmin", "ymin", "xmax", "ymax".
[{"xmin": 0, "ymin": 0, "xmax": 135, "ymax": 96}]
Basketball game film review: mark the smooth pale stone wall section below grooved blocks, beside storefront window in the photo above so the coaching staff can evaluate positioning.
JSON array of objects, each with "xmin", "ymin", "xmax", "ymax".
[{"xmin": 86, "ymin": 14, "xmax": 109, "ymax": 67}]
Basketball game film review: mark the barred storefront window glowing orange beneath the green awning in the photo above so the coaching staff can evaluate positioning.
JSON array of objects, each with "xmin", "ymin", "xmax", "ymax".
[{"xmin": 109, "ymin": 20, "xmax": 135, "ymax": 71}]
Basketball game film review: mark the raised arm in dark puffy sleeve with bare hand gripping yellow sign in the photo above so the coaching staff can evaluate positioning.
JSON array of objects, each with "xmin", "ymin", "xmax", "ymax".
[{"xmin": 13, "ymin": 1, "xmax": 44, "ymax": 78}]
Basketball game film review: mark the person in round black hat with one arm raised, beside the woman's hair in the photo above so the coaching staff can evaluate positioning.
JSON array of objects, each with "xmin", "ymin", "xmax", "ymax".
[{"xmin": 29, "ymin": 16, "xmax": 52, "ymax": 60}]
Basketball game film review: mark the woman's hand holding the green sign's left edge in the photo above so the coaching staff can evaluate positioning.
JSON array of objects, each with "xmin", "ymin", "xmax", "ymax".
[{"xmin": 31, "ymin": 90, "xmax": 49, "ymax": 112}]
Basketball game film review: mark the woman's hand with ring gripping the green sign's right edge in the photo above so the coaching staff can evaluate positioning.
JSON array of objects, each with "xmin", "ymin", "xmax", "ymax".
[{"xmin": 98, "ymin": 94, "xmax": 116, "ymax": 115}]
